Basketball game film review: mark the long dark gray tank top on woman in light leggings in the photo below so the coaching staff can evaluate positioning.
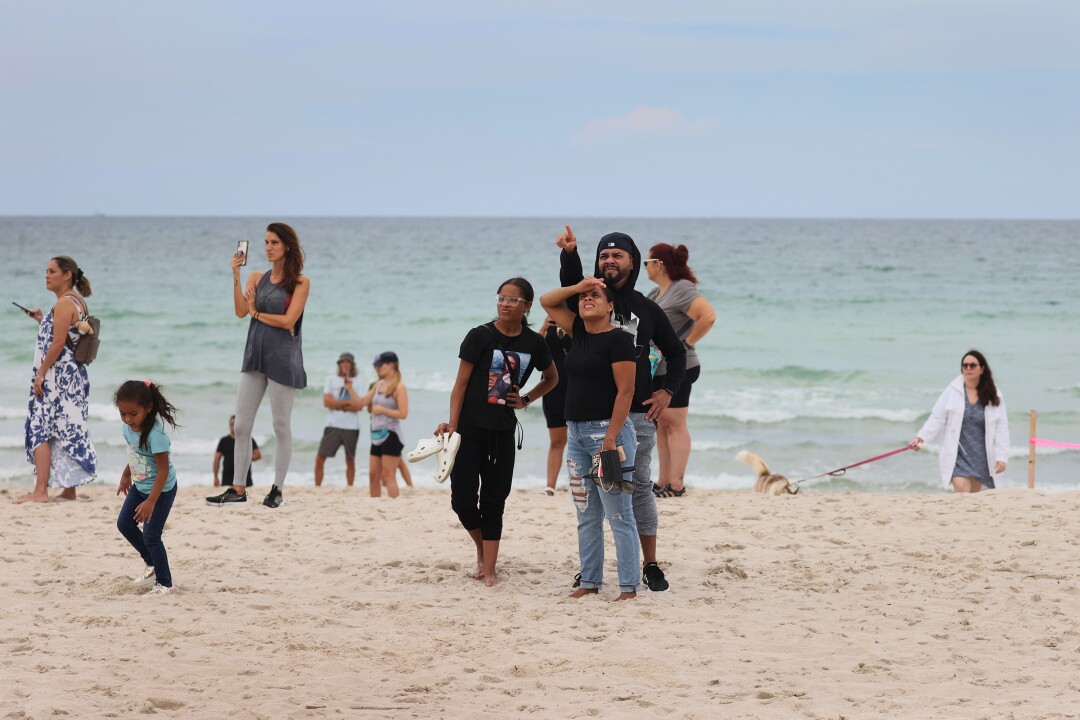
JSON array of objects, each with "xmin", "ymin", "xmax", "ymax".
[{"xmin": 241, "ymin": 272, "xmax": 308, "ymax": 389}]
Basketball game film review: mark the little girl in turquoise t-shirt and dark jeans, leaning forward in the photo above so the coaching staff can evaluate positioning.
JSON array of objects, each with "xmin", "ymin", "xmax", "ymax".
[{"xmin": 112, "ymin": 380, "xmax": 176, "ymax": 595}]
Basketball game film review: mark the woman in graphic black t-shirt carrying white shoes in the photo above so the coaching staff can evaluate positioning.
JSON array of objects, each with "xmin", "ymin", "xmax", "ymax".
[{"xmin": 435, "ymin": 277, "xmax": 558, "ymax": 587}]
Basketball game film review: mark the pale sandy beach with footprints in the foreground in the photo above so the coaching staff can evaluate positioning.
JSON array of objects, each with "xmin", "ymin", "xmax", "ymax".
[{"xmin": 0, "ymin": 478, "xmax": 1080, "ymax": 719}]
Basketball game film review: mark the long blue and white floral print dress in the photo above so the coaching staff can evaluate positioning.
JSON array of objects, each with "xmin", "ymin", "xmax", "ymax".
[{"xmin": 26, "ymin": 298, "xmax": 97, "ymax": 488}]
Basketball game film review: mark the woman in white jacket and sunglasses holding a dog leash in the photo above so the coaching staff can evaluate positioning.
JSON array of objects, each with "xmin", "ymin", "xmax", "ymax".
[{"xmin": 915, "ymin": 350, "xmax": 1009, "ymax": 492}]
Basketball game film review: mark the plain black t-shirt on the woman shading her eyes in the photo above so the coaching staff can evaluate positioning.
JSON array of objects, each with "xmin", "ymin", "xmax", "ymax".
[{"xmin": 565, "ymin": 317, "xmax": 636, "ymax": 420}]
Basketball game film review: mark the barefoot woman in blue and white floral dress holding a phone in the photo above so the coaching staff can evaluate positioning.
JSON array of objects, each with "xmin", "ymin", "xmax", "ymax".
[{"xmin": 15, "ymin": 256, "xmax": 97, "ymax": 503}]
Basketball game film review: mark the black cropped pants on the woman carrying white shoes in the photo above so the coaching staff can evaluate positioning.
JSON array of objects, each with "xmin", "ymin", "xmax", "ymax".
[{"xmin": 450, "ymin": 430, "xmax": 514, "ymax": 540}]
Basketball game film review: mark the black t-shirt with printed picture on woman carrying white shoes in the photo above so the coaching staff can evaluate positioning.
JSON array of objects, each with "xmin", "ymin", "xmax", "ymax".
[{"xmin": 458, "ymin": 323, "xmax": 551, "ymax": 432}]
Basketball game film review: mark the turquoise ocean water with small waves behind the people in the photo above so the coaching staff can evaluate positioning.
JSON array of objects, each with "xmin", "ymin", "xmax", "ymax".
[{"xmin": 0, "ymin": 217, "xmax": 1080, "ymax": 491}]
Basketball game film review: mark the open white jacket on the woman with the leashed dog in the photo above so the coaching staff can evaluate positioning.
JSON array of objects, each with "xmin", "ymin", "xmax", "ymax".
[{"xmin": 916, "ymin": 375, "xmax": 1009, "ymax": 488}]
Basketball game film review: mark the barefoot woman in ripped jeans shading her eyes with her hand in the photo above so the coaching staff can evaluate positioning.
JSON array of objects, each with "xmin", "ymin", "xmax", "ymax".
[{"xmin": 540, "ymin": 277, "xmax": 642, "ymax": 600}]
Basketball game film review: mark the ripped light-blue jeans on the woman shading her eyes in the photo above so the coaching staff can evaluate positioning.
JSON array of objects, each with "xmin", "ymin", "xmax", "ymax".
[{"xmin": 566, "ymin": 420, "xmax": 642, "ymax": 593}]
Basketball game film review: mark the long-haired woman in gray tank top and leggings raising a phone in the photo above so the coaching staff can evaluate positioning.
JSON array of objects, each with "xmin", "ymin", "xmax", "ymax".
[{"xmin": 206, "ymin": 222, "xmax": 311, "ymax": 507}]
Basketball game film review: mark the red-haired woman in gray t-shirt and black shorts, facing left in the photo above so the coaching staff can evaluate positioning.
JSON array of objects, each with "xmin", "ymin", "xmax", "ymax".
[{"xmin": 643, "ymin": 243, "xmax": 716, "ymax": 498}]
